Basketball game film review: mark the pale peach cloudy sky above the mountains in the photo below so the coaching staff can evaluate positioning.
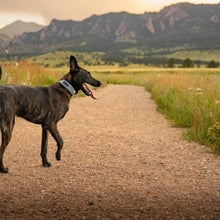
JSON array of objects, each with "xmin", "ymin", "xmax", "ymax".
[{"xmin": 0, "ymin": 0, "xmax": 220, "ymax": 28}]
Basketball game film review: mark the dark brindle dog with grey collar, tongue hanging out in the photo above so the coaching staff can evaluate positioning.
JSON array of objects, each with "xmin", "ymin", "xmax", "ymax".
[{"xmin": 0, "ymin": 55, "xmax": 101, "ymax": 173}]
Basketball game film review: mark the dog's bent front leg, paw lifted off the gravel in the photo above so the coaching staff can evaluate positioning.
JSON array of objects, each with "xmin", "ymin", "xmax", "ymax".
[{"xmin": 47, "ymin": 123, "xmax": 63, "ymax": 160}]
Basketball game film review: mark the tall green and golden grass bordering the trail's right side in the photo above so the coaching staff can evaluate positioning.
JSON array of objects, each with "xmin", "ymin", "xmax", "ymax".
[{"xmin": 147, "ymin": 71, "xmax": 220, "ymax": 154}]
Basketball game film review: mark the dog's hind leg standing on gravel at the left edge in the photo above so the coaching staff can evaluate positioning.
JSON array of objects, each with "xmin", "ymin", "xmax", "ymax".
[{"xmin": 0, "ymin": 119, "xmax": 14, "ymax": 173}]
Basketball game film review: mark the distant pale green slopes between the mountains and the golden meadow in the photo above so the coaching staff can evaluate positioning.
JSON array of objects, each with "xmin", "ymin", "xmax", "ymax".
[{"xmin": 28, "ymin": 48, "xmax": 220, "ymax": 68}]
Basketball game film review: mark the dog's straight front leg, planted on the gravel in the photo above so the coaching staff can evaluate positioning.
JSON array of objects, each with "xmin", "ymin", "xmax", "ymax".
[{"xmin": 41, "ymin": 125, "xmax": 51, "ymax": 167}]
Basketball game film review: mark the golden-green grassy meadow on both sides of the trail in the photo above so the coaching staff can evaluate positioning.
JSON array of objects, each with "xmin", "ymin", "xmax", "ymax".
[{"xmin": 1, "ymin": 61, "xmax": 220, "ymax": 154}]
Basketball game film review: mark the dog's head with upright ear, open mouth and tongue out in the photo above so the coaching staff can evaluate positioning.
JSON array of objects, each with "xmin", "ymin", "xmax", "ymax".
[{"xmin": 69, "ymin": 55, "xmax": 101, "ymax": 98}]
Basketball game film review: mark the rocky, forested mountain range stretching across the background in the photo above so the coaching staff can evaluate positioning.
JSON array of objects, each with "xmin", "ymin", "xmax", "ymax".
[{"xmin": 0, "ymin": 3, "xmax": 220, "ymax": 55}]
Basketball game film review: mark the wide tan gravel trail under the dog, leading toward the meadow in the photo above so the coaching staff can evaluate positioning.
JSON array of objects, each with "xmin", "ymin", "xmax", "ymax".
[{"xmin": 0, "ymin": 85, "xmax": 220, "ymax": 220}]
